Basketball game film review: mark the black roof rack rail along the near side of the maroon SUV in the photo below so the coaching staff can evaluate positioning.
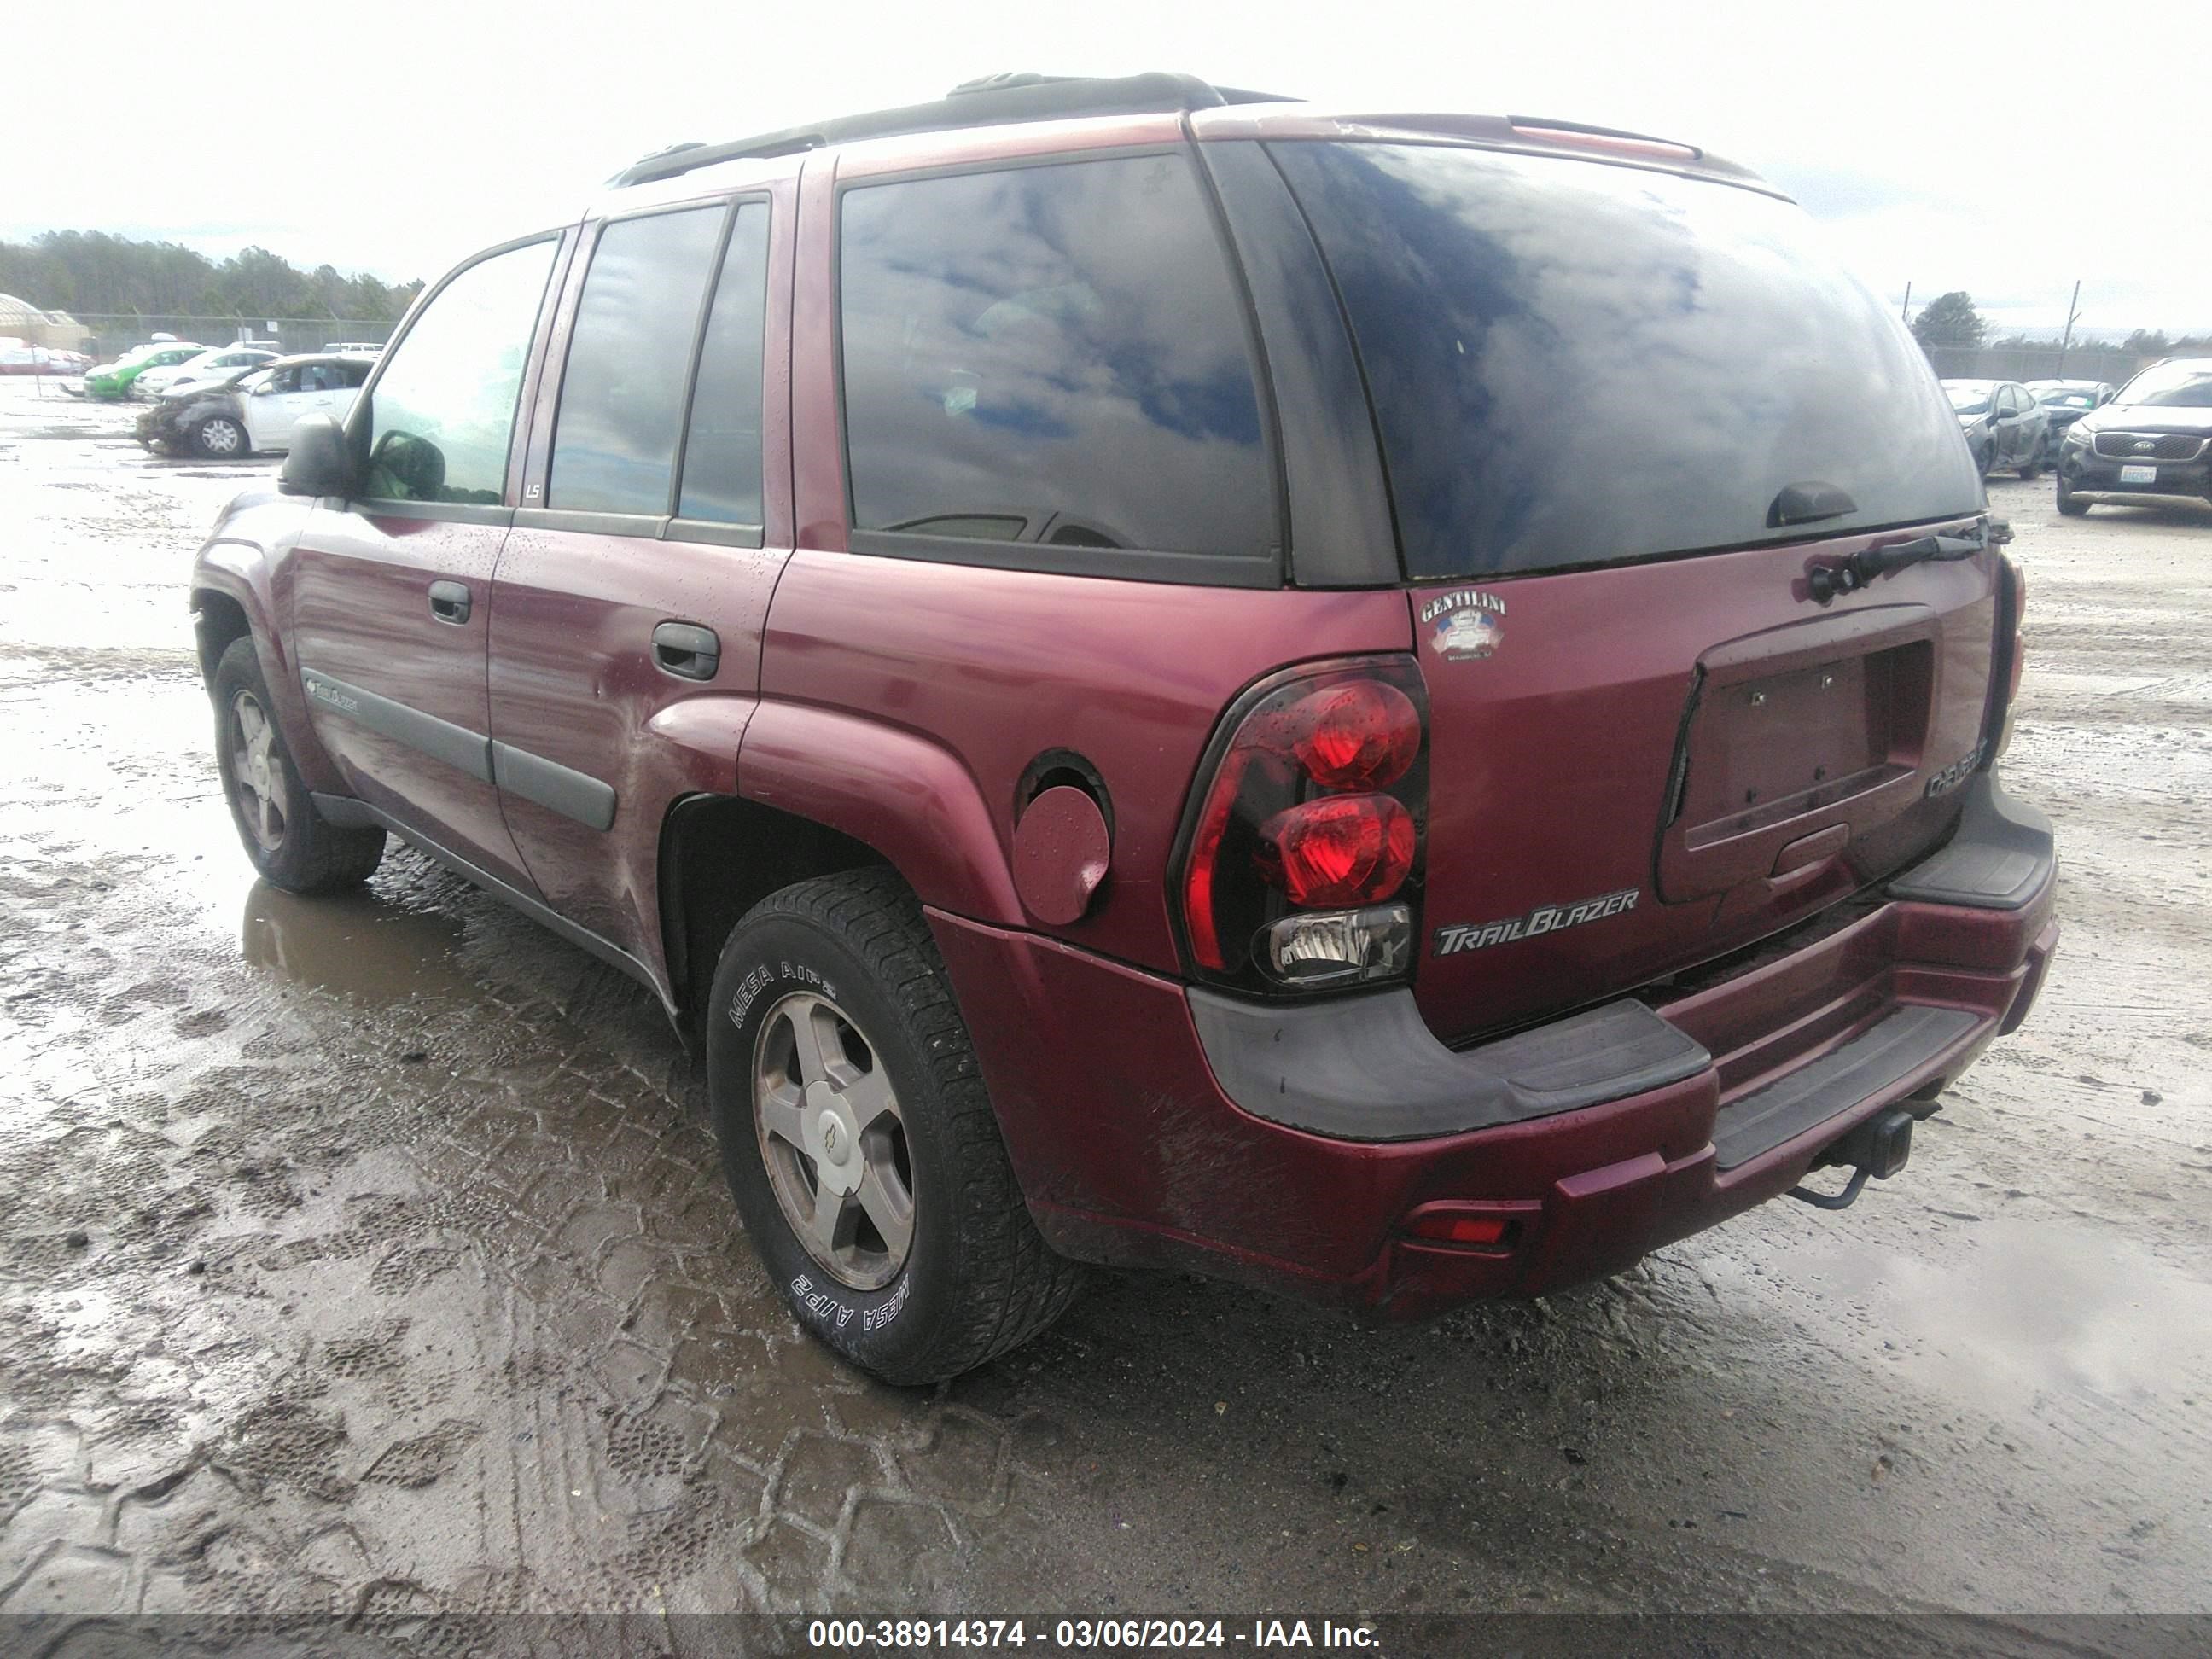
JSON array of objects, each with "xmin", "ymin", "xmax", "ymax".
[{"xmin": 608, "ymin": 73, "xmax": 1292, "ymax": 190}]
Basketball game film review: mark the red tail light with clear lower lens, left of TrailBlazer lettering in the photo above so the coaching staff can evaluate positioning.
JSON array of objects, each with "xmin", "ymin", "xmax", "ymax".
[{"xmin": 1177, "ymin": 657, "xmax": 1429, "ymax": 991}]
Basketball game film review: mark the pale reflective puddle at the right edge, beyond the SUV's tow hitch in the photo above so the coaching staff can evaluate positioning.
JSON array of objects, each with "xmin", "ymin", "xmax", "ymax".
[{"xmin": 1767, "ymin": 1219, "xmax": 2212, "ymax": 1400}]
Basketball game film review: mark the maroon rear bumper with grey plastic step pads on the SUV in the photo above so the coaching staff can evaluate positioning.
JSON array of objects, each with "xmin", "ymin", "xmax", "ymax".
[{"xmin": 931, "ymin": 774, "xmax": 2058, "ymax": 1318}]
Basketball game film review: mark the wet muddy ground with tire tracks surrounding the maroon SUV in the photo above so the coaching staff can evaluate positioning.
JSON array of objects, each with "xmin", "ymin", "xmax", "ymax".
[{"xmin": 0, "ymin": 382, "xmax": 2212, "ymax": 1645}]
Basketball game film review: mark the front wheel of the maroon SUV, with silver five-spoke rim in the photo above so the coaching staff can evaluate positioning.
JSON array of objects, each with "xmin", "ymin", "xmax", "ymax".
[{"xmin": 214, "ymin": 635, "xmax": 385, "ymax": 894}]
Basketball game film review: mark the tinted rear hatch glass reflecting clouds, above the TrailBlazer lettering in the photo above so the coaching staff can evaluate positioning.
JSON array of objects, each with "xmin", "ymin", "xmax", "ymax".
[{"xmin": 1270, "ymin": 142, "xmax": 1982, "ymax": 578}]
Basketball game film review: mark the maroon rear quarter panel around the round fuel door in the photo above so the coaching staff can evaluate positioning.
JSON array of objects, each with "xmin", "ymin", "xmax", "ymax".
[{"xmin": 739, "ymin": 549, "xmax": 1412, "ymax": 971}]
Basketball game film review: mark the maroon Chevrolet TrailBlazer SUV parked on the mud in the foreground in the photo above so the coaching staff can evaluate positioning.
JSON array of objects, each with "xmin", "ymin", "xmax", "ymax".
[{"xmin": 193, "ymin": 75, "xmax": 2058, "ymax": 1382}]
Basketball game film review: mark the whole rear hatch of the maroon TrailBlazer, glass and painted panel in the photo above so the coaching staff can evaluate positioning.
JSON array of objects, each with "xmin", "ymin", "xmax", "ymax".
[{"xmin": 1270, "ymin": 142, "xmax": 1998, "ymax": 1039}]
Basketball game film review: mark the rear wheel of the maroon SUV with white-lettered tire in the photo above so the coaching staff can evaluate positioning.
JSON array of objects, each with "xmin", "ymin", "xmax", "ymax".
[{"xmin": 707, "ymin": 870, "xmax": 1081, "ymax": 1385}]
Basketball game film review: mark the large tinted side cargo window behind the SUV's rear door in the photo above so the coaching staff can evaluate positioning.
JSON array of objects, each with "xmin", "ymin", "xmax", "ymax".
[{"xmin": 838, "ymin": 154, "xmax": 1274, "ymax": 570}]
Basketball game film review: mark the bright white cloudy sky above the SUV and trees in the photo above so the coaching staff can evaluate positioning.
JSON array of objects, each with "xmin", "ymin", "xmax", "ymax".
[{"xmin": 0, "ymin": 0, "xmax": 2212, "ymax": 332}]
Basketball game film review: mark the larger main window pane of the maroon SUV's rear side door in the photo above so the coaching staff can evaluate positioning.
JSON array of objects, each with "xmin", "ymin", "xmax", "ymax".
[{"xmin": 546, "ymin": 203, "xmax": 728, "ymax": 515}]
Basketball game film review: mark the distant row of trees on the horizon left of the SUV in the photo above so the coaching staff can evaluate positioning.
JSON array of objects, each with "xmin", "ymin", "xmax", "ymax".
[{"xmin": 0, "ymin": 230, "xmax": 422, "ymax": 323}]
